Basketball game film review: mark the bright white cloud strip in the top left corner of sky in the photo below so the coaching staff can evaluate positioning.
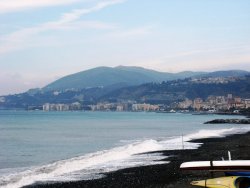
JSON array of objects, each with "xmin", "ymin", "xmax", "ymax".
[{"xmin": 0, "ymin": 0, "xmax": 80, "ymax": 13}]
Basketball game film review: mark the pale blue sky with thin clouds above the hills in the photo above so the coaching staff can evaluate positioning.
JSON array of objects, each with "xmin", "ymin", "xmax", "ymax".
[{"xmin": 0, "ymin": 0, "xmax": 250, "ymax": 95}]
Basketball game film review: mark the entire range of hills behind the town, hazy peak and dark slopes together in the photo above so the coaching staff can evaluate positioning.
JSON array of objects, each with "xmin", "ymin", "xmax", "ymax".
[{"xmin": 0, "ymin": 66, "xmax": 250, "ymax": 109}]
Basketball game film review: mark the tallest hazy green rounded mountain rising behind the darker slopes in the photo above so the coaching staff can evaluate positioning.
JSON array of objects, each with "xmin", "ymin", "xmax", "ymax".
[{"xmin": 43, "ymin": 66, "xmax": 204, "ymax": 91}]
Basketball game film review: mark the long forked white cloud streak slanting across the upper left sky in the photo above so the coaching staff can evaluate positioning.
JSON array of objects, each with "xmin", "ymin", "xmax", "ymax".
[{"xmin": 0, "ymin": 0, "xmax": 124, "ymax": 54}]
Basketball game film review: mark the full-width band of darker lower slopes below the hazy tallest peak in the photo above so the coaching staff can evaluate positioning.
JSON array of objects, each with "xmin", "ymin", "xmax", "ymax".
[{"xmin": 0, "ymin": 76, "xmax": 250, "ymax": 108}]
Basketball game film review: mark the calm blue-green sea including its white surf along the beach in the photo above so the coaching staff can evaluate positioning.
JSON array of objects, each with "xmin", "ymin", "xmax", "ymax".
[{"xmin": 0, "ymin": 110, "xmax": 250, "ymax": 188}]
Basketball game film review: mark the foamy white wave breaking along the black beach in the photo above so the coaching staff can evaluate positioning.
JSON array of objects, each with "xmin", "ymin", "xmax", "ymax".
[{"xmin": 0, "ymin": 127, "xmax": 250, "ymax": 188}]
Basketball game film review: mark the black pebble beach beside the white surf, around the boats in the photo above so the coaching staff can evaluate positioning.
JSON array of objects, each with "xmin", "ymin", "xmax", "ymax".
[{"xmin": 23, "ymin": 133, "xmax": 250, "ymax": 188}]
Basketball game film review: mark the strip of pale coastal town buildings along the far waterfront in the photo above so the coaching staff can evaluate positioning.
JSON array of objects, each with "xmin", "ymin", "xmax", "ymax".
[{"xmin": 42, "ymin": 94, "xmax": 250, "ymax": 113}]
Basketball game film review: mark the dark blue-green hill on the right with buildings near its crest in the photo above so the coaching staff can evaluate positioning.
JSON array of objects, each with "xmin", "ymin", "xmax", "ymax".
[{"xmin": 102, "ymin": 76, "xmax": 250, "ymax": 104}]
